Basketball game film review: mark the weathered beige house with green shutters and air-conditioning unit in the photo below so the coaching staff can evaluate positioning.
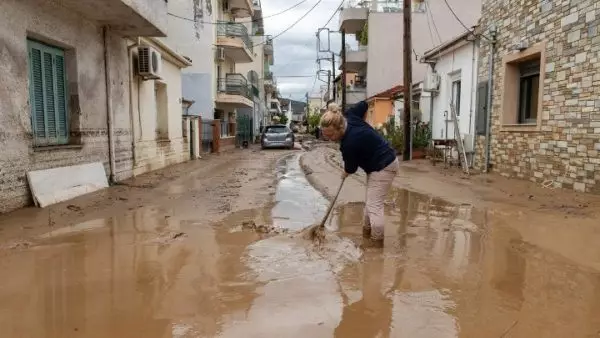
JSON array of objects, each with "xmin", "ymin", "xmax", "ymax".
[{"xmin": 0, "ymin": 0, "xmax": 197, "ymax": 212}]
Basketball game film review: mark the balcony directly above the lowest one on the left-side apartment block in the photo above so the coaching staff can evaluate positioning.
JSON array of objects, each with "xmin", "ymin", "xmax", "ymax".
[{"xmin": 217, "ymin": 22, "xmax": 254, "ymax": 63}]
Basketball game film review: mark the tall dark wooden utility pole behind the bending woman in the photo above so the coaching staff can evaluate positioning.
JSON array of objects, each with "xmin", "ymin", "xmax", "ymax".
[{"xmin": 404, "ymin": 0, "xmax": 412, "ymax": 161}]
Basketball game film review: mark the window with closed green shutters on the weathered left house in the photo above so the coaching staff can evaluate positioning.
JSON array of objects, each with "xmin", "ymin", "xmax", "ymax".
[{"xmin": 27, "ymin": 40, "xmax": 69, "ymax": 146}]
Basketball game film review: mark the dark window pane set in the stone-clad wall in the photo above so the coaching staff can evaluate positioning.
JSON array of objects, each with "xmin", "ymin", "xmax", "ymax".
[{"xmin": 518, "ymin": 60, "xmax": 540, "ymax": 124}]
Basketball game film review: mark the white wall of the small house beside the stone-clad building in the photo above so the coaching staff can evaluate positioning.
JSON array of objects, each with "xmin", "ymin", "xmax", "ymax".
[{"xmin": 422, "ymin": 43, "xmax": 479, "ymax": 139}]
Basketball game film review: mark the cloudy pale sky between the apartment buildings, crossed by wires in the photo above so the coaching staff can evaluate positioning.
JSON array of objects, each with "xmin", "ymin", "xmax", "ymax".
[{"xmin": 261, "ymin": 0, "xmax": 350, "ymax": 100}]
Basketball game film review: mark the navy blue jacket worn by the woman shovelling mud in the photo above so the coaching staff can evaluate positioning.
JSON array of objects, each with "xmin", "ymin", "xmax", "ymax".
[{"xmin": 340, "ymin": 101, "xmax": 396, "ymax": 174}]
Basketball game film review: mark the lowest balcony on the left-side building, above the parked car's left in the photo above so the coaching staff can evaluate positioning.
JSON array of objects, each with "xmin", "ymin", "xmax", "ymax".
[{"xmin": 216, "ymin": 74, "xmax": 254, "ymax": 110}]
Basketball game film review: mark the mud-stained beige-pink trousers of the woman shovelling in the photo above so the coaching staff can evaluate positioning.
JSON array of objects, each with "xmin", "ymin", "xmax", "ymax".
[{"xmin": 364, "ymin": 159, "xmax": 400, "ymax": 240}]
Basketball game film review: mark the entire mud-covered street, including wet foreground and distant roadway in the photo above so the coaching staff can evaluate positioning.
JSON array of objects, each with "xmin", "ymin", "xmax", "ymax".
[{"xmin": 0, "ymin": 147, "xmax": 600, "ymax": 338}]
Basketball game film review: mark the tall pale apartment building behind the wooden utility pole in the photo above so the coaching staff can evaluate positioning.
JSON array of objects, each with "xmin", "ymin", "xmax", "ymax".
[{"xmin": 339, "ymin": 0, "xmax": 481, "ymax": 125}]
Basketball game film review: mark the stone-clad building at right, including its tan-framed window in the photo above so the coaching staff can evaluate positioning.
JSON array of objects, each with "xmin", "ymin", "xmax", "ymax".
[{"xmin": 476, "ymin": 0, "xmax": 600, "ymax": 193}]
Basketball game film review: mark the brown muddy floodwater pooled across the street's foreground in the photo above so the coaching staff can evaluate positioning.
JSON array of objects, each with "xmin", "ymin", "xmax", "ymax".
[{"xmin": 0, "ymin": 155, "xmax": 600, "ymax": 338}]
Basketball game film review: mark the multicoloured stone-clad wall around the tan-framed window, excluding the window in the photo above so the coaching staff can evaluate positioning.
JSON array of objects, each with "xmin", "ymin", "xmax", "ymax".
[{"xmin": 476, "ymin": 0, "xmax": 600, "ymax": 193}]
